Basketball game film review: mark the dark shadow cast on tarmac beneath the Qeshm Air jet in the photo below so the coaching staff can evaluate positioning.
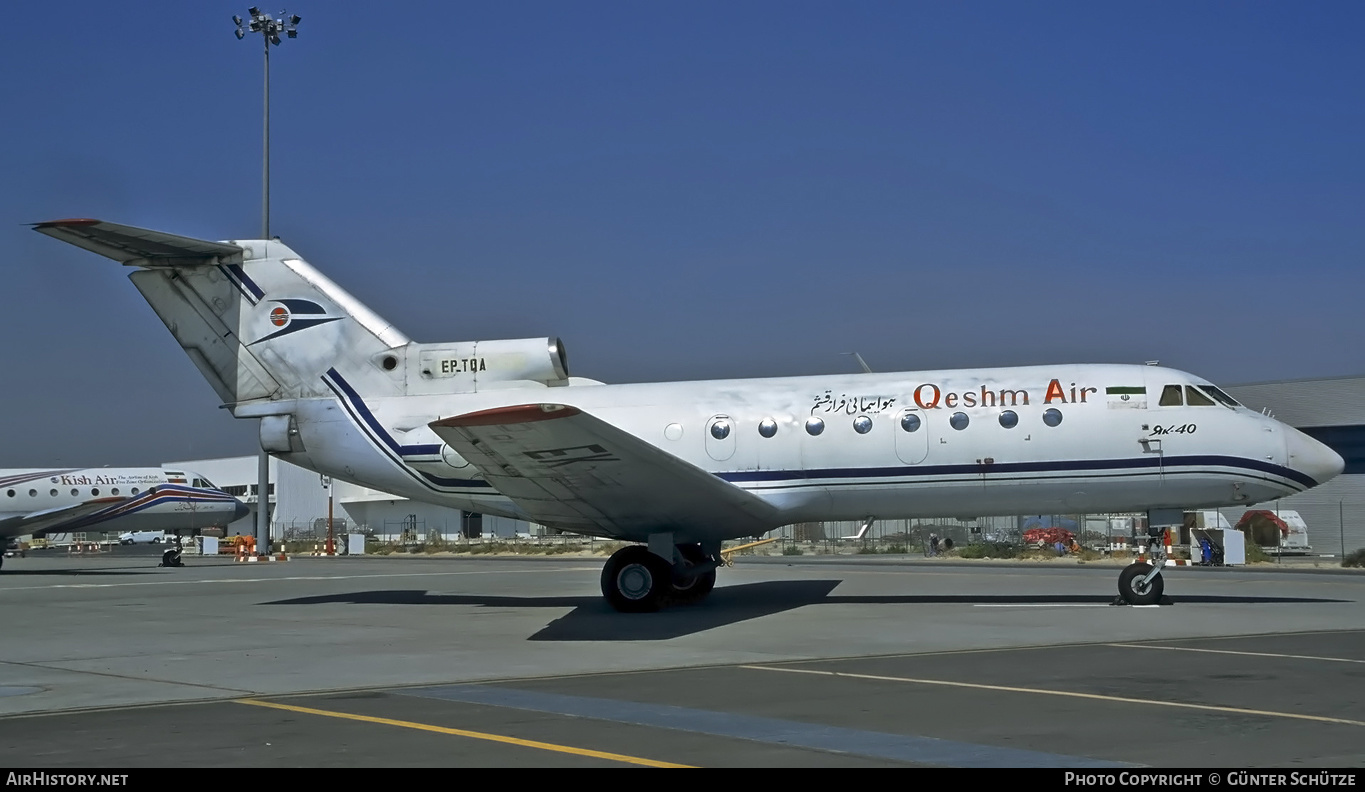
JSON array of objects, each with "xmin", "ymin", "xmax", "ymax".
[{"xmin": 257, "ymin": 580, "xmax": 1351, "ymax": 640}]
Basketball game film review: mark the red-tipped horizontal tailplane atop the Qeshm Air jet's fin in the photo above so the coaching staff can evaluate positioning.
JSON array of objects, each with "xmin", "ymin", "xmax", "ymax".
[{"xmin": 33, "ymin": 220, "xmax": 243, "ymax": 266}]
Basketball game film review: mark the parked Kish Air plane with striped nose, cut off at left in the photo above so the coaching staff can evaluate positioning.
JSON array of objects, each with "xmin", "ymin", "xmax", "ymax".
[{"xmin": 0, "ymin": 467, "xmax": 250, "ymax": 565}]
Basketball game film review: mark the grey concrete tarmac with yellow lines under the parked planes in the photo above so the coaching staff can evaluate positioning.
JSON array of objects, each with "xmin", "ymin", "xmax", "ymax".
[{"xmin": 0, "ymin": 548, "xmax": 1365, "ymax": 770}]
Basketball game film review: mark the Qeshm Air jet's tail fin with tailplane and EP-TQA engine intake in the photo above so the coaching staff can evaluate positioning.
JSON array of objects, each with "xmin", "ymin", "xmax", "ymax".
[{"xmin": 34, "ymin": 214, "xmax": 591, "ymax": 416}]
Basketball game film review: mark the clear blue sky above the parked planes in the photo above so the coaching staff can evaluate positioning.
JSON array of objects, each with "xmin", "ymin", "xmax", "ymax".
[{"xmin": 0, "ymin": 0, "xmax": 1365, "ymax": 467}]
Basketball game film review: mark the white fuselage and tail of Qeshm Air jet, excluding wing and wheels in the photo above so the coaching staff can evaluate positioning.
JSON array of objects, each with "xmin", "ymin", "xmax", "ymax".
[{"xmin": 35, "ymin": 218, "xmax": 1345, "ymax": 552}]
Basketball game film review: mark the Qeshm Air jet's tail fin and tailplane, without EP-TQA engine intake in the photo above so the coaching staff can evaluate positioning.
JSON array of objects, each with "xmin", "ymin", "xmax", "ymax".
[{"xmin": 34, "ymin": 220, "xmax": 410, "ymax": 407}]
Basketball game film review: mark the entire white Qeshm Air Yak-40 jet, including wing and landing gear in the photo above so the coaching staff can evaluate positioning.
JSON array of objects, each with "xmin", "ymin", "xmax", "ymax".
[{"xmin": 34, "ymin": 220, "xmax": 1343, "ymax": 612}]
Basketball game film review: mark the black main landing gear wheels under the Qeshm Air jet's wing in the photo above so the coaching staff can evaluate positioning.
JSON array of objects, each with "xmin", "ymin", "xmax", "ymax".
[{"xmin": 602, "ymin": 534, "xmax": 721, "ymax": 613}]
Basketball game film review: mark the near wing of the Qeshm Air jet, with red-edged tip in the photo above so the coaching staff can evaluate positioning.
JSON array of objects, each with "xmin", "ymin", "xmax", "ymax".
[{"xmin": 430, "ymin": 404, "xmax": 781, "ymax": 541}]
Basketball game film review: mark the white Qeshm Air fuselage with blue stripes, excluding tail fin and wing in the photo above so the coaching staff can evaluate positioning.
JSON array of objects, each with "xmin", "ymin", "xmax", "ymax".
[{"xmin": 274, "ymin": 365, "xmax": 1335, "ymax": 538}]
